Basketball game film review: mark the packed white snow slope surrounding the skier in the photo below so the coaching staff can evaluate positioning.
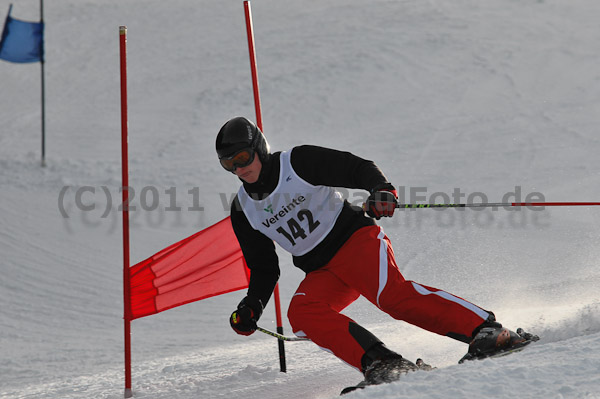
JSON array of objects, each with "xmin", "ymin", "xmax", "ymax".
[{"xmin": 0, "ymin": 0, "xmax": 600, "ymax": 399}]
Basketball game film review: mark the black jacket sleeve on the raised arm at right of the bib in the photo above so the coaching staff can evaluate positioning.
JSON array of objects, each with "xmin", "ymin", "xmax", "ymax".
[{"xmin": 291, "ymin": 145, "xmax": 393, "ymax": 191}]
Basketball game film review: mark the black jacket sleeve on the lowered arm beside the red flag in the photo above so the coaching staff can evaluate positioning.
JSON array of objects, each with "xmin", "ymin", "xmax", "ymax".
[{"xmin": 231, "ymin": 196, "xmax": 279, "ymax": 306}]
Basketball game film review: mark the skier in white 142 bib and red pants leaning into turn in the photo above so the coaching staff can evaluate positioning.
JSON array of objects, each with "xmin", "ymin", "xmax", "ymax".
[{"xmin": 216, "ymin": 117, "xmax": 536, "ymax": 385}]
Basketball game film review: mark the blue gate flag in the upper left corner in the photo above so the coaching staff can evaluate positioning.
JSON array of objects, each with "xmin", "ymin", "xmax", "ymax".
[{"xmin": 0, "ymin": 4, "xmax": 44, "ymax": 63}]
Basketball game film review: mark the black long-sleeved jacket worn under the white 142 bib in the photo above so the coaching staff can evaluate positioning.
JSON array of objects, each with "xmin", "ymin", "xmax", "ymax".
[{"xmin": 231, "ymin": 145, "xmax": 393, "ymax": 305}]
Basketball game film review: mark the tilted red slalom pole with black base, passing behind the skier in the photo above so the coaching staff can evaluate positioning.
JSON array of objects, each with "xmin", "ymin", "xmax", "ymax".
[{"xmin": 244, "ymin": 1, "xmax": 287, "ymax": 373}]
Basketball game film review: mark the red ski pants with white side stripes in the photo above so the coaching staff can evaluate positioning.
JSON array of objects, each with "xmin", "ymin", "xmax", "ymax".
[{"xmin": 288, "ymin": 226, "xmax": 489, "ymax": 371}]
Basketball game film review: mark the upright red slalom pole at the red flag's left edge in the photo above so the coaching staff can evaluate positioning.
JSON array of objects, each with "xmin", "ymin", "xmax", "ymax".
[{"xmin": 119, "ymin": 26, "xmax": 133, "ymax": 398}]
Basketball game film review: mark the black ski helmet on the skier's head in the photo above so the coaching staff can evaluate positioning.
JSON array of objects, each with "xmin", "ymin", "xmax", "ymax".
[{"xmin": 216, "ymin": 116, "xmax": 271, "ymax": 163}]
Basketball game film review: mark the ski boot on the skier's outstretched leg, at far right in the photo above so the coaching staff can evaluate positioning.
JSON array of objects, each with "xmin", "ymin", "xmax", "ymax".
[{"xmin": 458, "ymin": 322, "xmax": 540, "ymax": 363}]
